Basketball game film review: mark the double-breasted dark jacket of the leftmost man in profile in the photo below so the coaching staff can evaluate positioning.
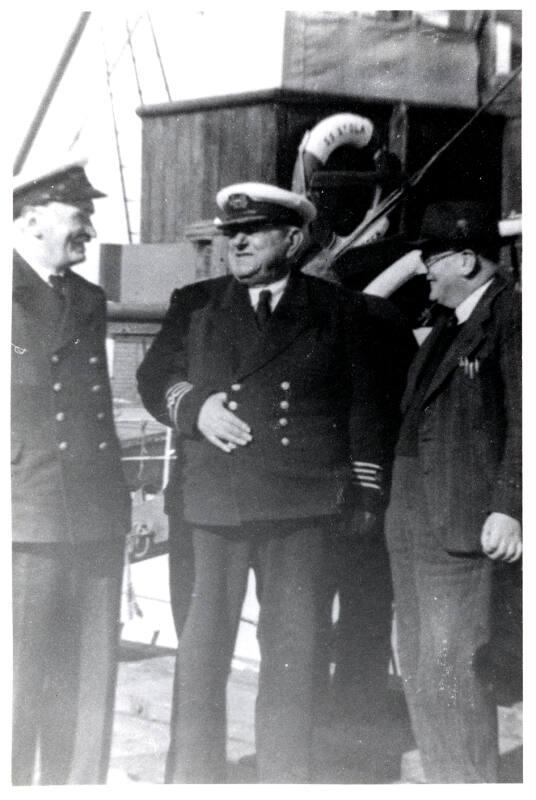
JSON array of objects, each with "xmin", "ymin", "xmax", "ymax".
[{"xmin": 11, "ymin": 253, "xmax": 130, "ymax": 543}]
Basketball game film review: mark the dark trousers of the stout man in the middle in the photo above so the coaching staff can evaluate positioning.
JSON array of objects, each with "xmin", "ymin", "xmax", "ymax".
[{"xmin": 166, "ymin": 520, "xmax": 324, "ymax": 783}]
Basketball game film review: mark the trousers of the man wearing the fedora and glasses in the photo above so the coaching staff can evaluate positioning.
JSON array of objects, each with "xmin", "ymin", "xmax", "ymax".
[{"xmin": 386, "ymin": 458, "xmax": 498, "ymax": 783}]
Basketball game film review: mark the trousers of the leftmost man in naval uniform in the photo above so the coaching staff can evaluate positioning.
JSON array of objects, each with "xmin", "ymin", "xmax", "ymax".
[{"xmin": 12, "ymin": 539, "xmax": 124, "ymax": 785}]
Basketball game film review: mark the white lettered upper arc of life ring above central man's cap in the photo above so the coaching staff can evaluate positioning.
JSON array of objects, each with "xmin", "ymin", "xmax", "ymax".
[{"xmin": 292, "ymin": 113, "xmax": 376, "ymax": 194}]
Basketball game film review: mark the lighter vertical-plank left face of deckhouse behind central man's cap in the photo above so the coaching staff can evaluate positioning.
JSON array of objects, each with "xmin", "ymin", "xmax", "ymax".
[{"xmin": 142, "ymin": 104, "xmax": 277, "ymax": 242}]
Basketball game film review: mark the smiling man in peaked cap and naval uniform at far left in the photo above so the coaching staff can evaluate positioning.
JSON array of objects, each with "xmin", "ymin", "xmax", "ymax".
[{"xmin": 11, "ymin": 162, "xmax": 130, "ymax": 785}]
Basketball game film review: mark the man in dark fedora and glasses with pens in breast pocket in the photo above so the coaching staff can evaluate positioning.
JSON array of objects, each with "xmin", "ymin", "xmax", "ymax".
[{"xmin": 387, "ymin": 201, "xmax": 521, "ymax": 783}]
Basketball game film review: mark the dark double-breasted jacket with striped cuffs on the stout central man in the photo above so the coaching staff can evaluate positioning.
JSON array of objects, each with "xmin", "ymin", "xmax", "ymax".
[{"xmin": 138, "ymin": 272, "xmax": 413, "ymax": 526}]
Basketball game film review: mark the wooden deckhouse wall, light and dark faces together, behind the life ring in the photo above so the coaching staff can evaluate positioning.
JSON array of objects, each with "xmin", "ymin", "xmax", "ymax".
[{"xmin": 141, "ymin": 92, "xmax": 503, "ymax": 242}]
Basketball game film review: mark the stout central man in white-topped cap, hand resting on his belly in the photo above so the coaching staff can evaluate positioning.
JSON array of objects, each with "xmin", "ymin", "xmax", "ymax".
[{"xmin": 138, "ymin": 183, "xmax": 411, "ymax": 783}]
